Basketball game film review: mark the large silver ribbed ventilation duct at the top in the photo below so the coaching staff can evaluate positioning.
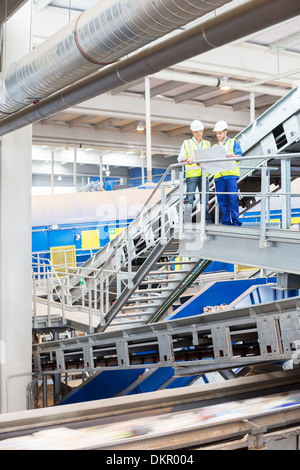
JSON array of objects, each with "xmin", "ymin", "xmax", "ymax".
[{"xmin": 0, "ymin": 0, "xmax": 229, "ymax": 117}]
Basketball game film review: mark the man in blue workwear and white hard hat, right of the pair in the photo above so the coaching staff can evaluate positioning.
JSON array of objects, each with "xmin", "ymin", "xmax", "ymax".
[{"xmin": 214, "ymin": 121, "xmax": 243, "ymax": 226}]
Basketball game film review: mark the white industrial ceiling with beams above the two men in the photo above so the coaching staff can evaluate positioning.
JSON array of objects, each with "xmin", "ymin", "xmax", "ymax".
[{"xmin": 2, "ymin": 0, "xmax": 300, "ymax": 189}]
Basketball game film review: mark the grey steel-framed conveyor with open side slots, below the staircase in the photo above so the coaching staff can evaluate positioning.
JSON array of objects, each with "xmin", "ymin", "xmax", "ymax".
[{"xmin": 33, "ymin": 297, "xmax": 300, "ymax": 375}]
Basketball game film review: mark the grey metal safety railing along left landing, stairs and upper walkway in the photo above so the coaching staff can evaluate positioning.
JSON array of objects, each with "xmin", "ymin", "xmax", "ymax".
[{"xmin": 33, "ymin": 153, "xmax": 300, "ymax": 332}]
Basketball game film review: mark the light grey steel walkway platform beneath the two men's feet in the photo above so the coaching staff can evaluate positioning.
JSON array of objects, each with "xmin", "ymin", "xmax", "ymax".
[{"xmin": 179, "ymin": 224, "xmax": 300, "ymax": 275}]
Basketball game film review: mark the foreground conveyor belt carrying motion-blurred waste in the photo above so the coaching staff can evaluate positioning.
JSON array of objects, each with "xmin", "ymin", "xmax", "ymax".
[{"xmin": 0, "ymin": 370, "xmax": 300, "ymax": 455}]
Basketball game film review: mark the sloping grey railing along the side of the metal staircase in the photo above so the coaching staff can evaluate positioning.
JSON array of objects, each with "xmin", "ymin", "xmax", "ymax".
[{"xmin": 57, "ymin": 182, "xmax": 179, "ymax": 303}]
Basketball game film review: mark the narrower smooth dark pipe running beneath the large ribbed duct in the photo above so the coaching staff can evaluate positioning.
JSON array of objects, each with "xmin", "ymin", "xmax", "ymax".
[{"xmin": 0, "ymin": 0, "xmax": 300, "ymax": 135}]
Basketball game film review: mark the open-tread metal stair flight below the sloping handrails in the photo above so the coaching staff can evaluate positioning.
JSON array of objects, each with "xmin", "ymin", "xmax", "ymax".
[{"xmin": 96, "ymin": 238, "xmax": 208, "ymax": 332}]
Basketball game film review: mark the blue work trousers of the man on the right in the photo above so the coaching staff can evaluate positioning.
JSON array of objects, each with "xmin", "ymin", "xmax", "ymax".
[{"xmin": 215, "ymin": 176, "xmax": 242, "ymax": 226}]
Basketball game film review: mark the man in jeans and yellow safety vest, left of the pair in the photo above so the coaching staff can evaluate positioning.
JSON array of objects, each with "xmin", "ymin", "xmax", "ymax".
[{"xmin": 178, "ymin": 119, "xmax": 211, "ymax": 224}]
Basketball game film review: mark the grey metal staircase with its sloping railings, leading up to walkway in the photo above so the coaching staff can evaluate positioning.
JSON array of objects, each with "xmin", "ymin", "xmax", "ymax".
[{"xmin": 49, "ymin": 179, "xmax": 209, "ymax": 332}]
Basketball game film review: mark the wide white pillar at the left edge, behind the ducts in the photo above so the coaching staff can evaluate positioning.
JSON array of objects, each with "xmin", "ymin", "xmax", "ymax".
[{"xmin": 0, "ymin": 1, "xmax": 32, "ymax": 413}]
